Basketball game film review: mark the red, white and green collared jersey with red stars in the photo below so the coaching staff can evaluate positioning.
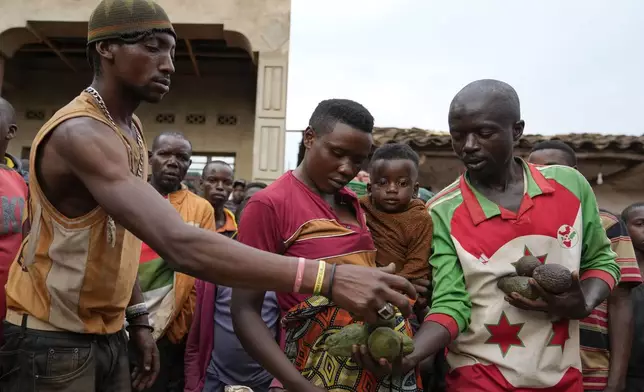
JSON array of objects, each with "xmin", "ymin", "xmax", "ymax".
[{"xmin": 427, "ymin": 161, "xmax": 620, "ymax": 392}]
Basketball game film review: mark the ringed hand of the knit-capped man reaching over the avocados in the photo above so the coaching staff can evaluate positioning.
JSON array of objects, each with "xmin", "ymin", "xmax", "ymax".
[{"xmin": 332, "ymin": 264, "xmax": 416, "ymax": 323}]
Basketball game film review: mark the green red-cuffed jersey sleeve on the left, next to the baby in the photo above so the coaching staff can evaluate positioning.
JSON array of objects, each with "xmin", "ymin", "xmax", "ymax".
[{"xmin": 425, "ymin": 210, "xmax": 472, "ymax": 339}]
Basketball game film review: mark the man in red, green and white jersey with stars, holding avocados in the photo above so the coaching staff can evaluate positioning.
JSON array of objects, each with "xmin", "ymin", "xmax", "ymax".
[{"xmin": 428, "ymin": 80, "xmax": 620, "ymax": 392}]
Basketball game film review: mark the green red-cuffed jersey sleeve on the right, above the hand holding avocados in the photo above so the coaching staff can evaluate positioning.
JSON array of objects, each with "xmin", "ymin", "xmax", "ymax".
[{"xmin": 579, "ymin": 174, "xmax": 620, "ymax": 290}]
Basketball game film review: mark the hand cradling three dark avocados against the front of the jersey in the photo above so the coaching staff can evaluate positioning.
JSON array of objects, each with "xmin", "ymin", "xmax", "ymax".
[{"xmin": 506, "ymin": 271, "xmax": 592, "ymax": 320}]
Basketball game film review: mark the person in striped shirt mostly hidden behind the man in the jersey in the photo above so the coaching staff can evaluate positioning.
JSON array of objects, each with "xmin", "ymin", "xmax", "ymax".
[{"xmin": 528, "ymin": 140, "xmax": 642, "ymax": 392}]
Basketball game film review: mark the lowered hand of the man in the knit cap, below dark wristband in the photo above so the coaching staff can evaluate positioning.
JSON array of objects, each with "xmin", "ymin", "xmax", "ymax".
[{"xmin": 129, "ymin": 327, "xmax": 161, "ymax": 391}]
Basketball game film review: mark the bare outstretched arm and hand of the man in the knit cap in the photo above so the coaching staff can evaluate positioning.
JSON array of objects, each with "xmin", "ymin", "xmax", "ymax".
[{"xmin": 48, "ymin": 117, "xmax": 416, "ymax": 321}]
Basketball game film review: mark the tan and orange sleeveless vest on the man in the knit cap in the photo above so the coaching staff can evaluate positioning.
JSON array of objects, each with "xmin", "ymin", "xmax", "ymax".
[{"xmin": 6, "ymin": 92, "xmax": 148, "ymax": 334}]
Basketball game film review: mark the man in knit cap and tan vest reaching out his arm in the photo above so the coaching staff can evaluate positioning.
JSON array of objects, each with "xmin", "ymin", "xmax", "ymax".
[{"xmin": 0, "ymin": 0, "xmax": 416, "ymax": 392}]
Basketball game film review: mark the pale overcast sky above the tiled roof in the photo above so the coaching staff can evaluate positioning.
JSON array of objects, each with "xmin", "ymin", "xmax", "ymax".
[{"xmin": 286, "ymin": 0, "xmax": 644, "ymax": 168}]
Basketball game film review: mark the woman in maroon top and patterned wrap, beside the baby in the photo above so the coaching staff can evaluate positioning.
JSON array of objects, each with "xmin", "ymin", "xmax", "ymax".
[{"xmin": 232, "ymin": 99, "xmax": 417, "ymax": 392}]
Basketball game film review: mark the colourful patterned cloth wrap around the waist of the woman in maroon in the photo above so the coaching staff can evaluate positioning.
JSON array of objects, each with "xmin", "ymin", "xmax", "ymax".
[{"xmin": 282, "ymin": 296, "xmax": 423, "ymax": 392}]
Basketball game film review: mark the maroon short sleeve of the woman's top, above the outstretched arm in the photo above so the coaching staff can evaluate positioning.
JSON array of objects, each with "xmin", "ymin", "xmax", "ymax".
[{"xmin": 237, "ymin": 199, "xmax": 284, "ymax": 253}]
